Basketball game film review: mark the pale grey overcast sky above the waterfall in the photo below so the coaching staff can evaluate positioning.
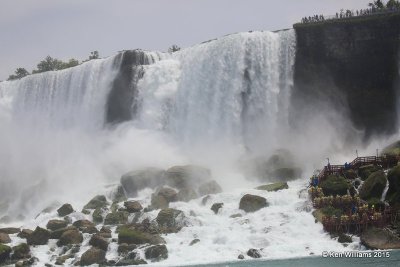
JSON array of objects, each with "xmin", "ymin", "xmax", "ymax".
[{"xmin": 0, "ymin": 0, "xmax": 371, "ymax": 80}]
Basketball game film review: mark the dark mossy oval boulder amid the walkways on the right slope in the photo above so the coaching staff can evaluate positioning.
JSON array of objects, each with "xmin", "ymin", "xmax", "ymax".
[{"xmin": 359, "ymin": 171, "xmax": 387, "ymax": 200}]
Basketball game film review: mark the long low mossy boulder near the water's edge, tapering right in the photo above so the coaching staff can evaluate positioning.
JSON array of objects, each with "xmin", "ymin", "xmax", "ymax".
[{"xmin": 118, "ymin": 227, "xmax": 165, "ymax": 245}]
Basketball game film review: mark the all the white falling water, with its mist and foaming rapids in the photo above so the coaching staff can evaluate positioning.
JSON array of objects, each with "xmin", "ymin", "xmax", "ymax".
[{"xmin": 0, "ymin": 31, "xmax": 368, "ymax": 265}]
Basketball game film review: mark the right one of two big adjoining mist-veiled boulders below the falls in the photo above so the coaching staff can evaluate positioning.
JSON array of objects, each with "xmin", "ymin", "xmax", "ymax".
[{"xmin": 165, "ymin": 165, "xmax": 211, "ymax": 189}]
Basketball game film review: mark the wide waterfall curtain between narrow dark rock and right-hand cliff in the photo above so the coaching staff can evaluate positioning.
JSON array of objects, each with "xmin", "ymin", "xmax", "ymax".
[{"xmin": 138, "ymin": 31, "xmax": 295, "ymax": 154}]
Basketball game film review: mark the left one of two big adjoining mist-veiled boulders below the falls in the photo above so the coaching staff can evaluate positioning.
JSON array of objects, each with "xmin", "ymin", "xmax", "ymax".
[{"xmin": 121, "ymin": 168, "xmax": 165, "ymax": 197}]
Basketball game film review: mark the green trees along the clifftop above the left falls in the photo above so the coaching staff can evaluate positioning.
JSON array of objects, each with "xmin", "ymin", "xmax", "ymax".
[{"xmin": 7, "ymin": 51, "xmax": 100, "ymax": 81}]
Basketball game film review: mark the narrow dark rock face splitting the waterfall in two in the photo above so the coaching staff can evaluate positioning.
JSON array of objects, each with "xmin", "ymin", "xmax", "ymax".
[{"xmin": 106, "ymin": 50, "xmax": 158, "ymax": 123}]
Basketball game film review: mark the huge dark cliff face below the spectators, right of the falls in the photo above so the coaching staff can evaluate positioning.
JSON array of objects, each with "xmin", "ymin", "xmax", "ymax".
[{"xmin": 292, "ymin": 13, "xmax": 400, "ymax": 137}]
